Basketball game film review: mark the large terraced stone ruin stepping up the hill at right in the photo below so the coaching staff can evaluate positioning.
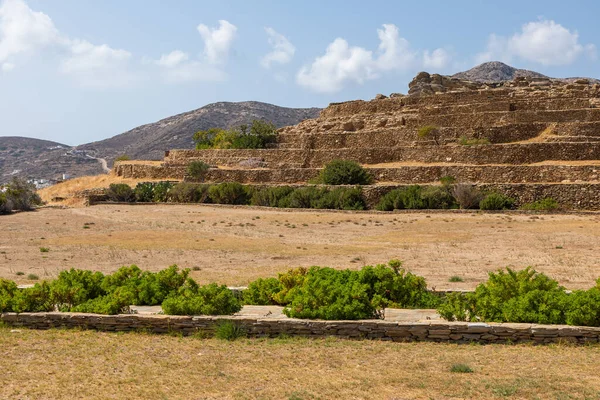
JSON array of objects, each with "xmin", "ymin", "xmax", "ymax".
[{"xmin": 113, "ymin": 72, "xmax": 600, "ymax": 210}]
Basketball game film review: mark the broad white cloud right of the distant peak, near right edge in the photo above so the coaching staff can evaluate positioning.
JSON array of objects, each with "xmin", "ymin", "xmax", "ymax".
[{"xmin": 476, "ymin": 19, "xmax": 596, "ymax": 66}]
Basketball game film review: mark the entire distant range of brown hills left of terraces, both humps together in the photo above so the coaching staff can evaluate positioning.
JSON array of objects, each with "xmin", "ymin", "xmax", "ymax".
[{"xmin": 0, "ymin": 101, "xmax": 320, "ymax": 184}]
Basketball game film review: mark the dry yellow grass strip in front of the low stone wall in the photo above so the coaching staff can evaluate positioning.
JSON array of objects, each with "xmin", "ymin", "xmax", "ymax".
[{"xmin": 0, "ymin": 328, "xmax": 600, "ymax": 400}]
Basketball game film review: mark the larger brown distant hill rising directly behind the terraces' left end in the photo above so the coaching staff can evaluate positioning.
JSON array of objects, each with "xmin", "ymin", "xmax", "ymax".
[{"xmin": 77, "ymin": 101, "xmax": 320, "ymax": 165}]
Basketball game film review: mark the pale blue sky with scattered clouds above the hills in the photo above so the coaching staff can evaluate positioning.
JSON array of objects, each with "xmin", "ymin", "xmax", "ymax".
[{"xmin": 0, "ymin": 0, "xmax": 600, "ymax": 145}]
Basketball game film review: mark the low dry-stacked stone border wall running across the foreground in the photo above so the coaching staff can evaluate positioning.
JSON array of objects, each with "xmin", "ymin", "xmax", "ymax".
[{"xmin": 0, "ymin": 313, "xmax": 600, "ymax": 344}]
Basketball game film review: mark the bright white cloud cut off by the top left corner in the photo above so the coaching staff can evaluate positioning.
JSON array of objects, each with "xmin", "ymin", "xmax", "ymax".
[{"xmin": 0, "ymin": 0, "xmax": 60, "ymax": 62}]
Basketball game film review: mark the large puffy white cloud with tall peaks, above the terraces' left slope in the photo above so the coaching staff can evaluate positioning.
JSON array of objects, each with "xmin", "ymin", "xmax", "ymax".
[{"xmin": 296, "ymin": 24, "xmax": 450, "ymax": 93}]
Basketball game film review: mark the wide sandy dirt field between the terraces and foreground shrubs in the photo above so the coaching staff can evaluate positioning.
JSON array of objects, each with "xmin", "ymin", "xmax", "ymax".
[{"xmin": 0, "ymin": 205, "xmax": 600, "ymax": 289}]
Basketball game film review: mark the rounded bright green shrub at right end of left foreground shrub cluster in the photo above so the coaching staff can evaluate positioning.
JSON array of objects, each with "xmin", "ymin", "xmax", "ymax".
[{"xmin": 162, "ymin": 279, "xmax": 242, "ymax": 315}]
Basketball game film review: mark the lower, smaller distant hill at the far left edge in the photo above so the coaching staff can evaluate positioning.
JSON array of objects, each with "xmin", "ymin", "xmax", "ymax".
[{"xmin": 0, "ymin": 136, "xmax": 102, "ymax": 184}]
